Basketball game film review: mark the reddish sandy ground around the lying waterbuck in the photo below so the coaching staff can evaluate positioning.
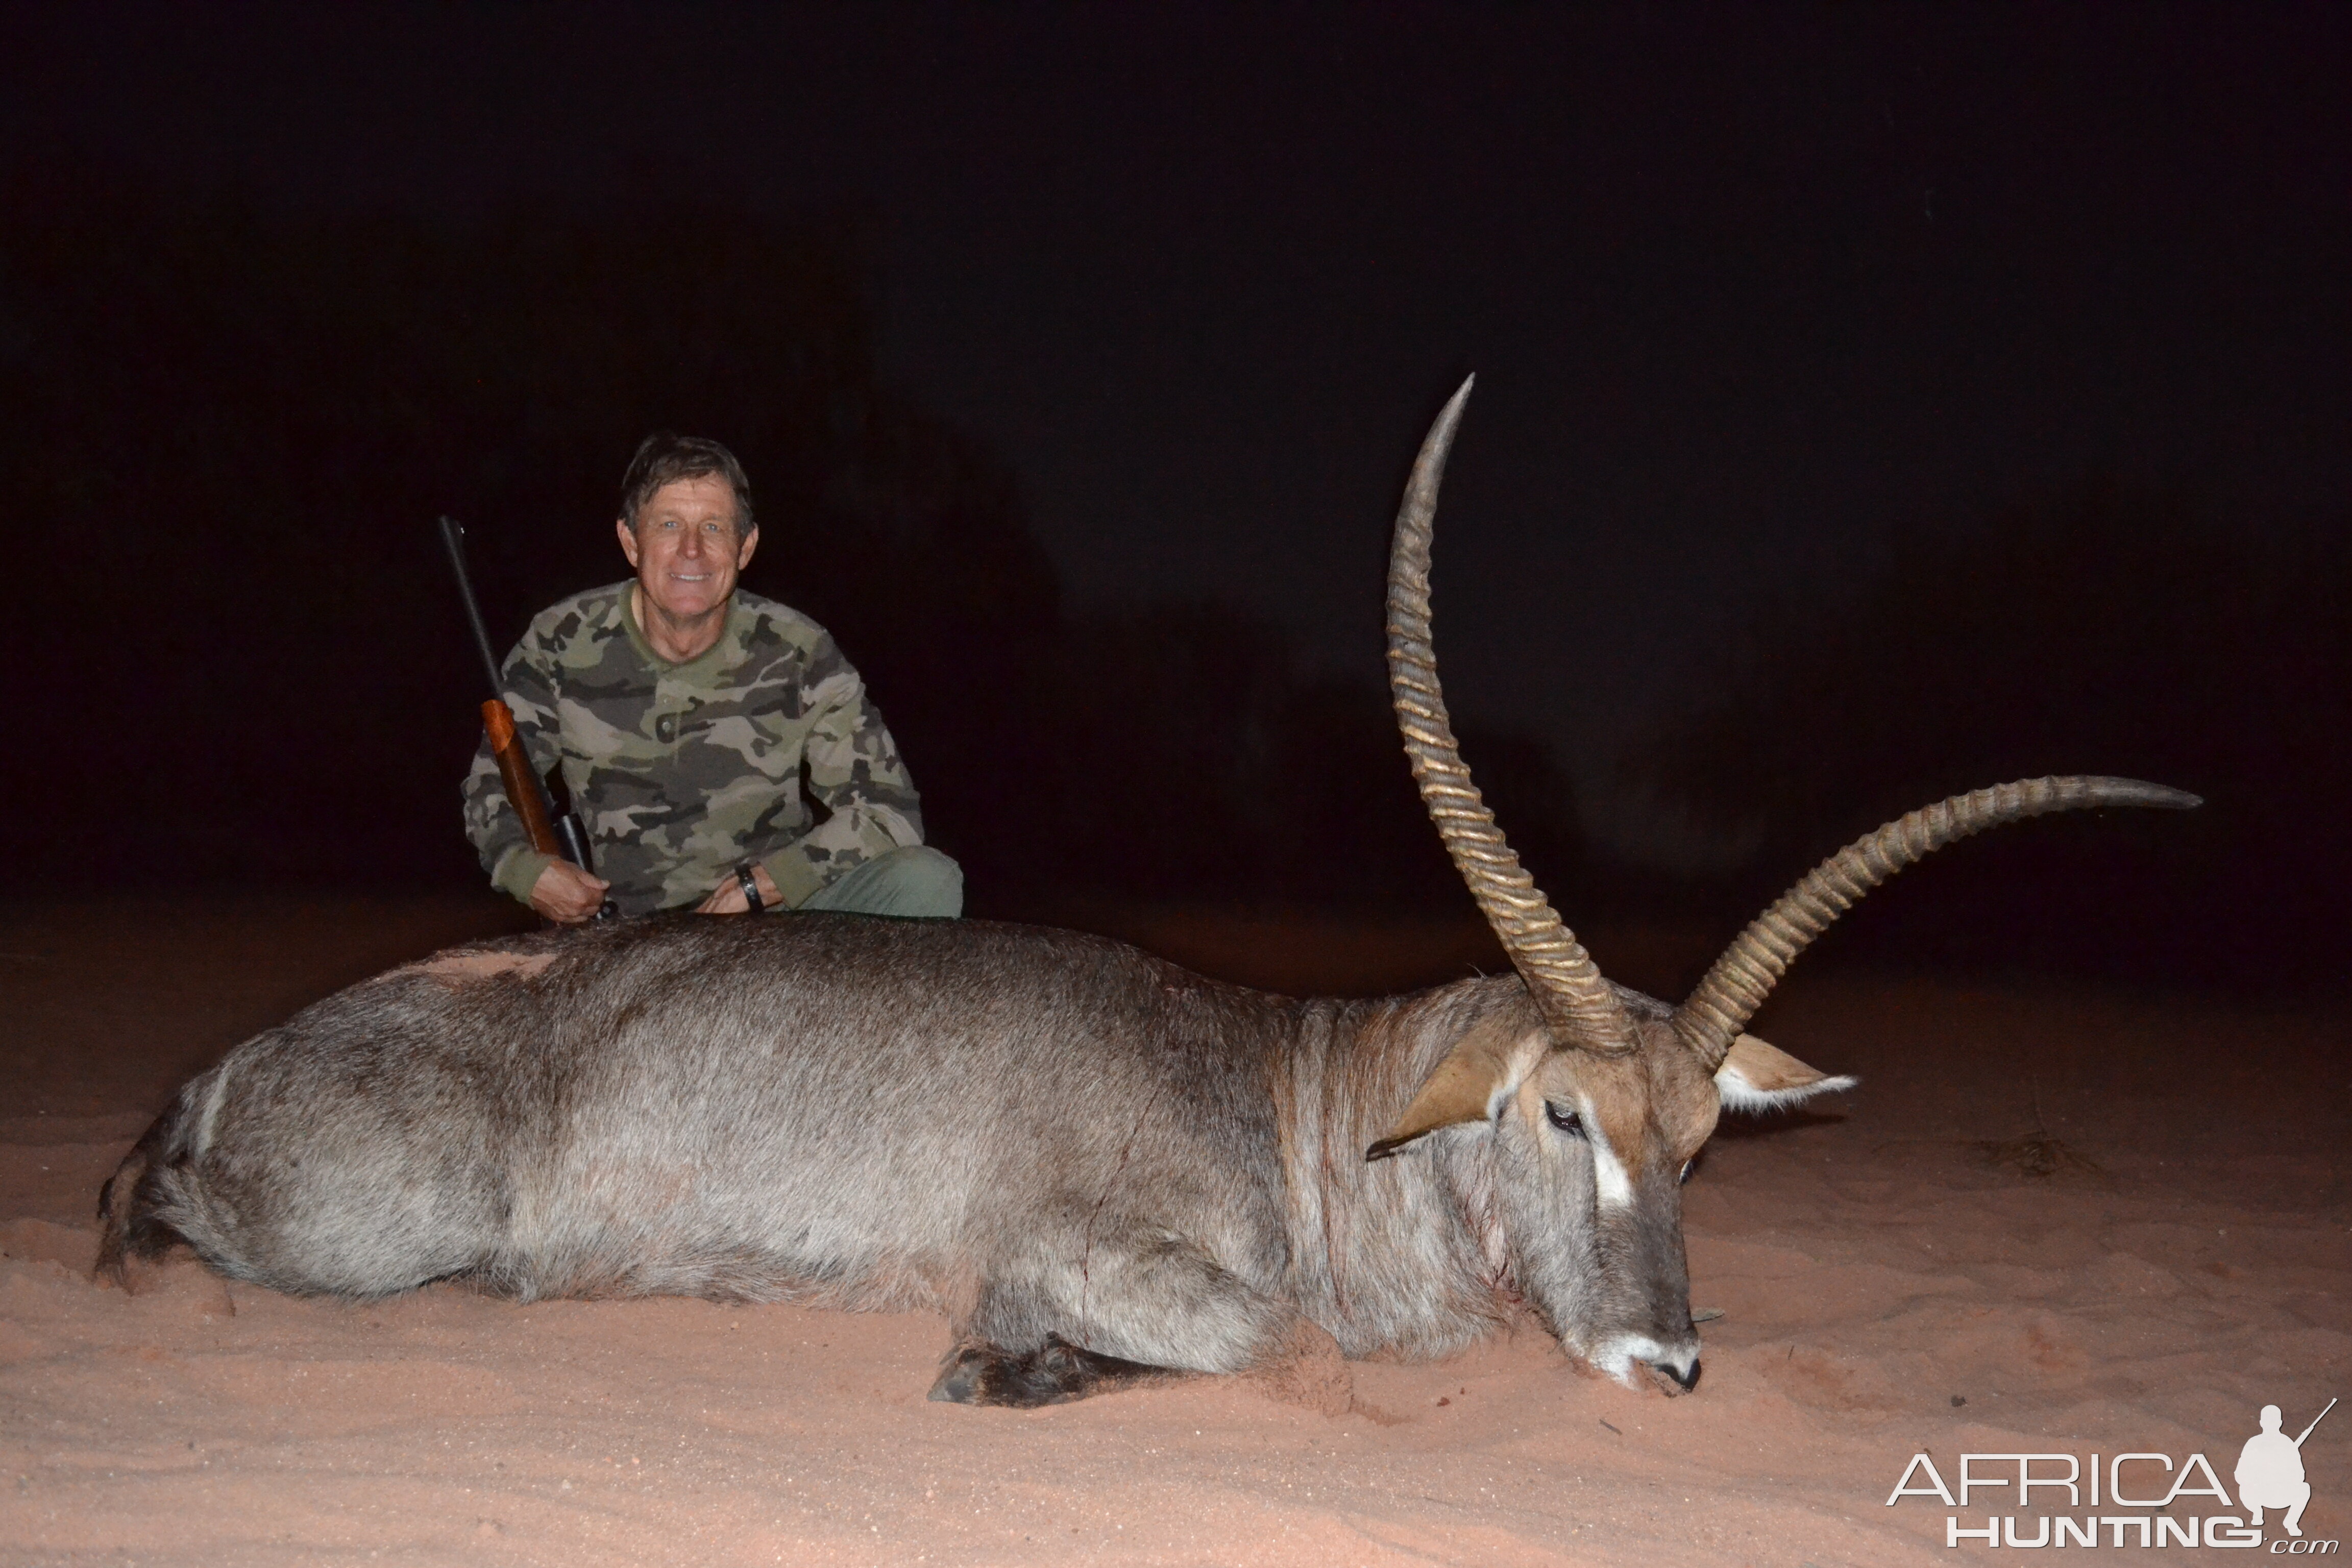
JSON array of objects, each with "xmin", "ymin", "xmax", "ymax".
[{"xmin": 0, "ymin": 900, "xmax": 2352, "ymax": 1568}]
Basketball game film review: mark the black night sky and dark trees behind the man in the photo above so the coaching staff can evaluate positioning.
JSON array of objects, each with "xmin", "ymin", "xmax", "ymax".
[{"xmin": 0, "ymin": 5, "xmax": 2352, "ymax": 990}]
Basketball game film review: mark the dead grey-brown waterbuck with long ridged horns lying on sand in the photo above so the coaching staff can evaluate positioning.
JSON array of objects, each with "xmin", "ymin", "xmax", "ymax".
[{"xmin": 99, "ymin": 383, "xmax": 2197, "ymax": 1406}]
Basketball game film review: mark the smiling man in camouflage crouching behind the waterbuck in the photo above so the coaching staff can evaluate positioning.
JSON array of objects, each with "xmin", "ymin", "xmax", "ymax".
[{"xmin": 465, "ymin": 432, "xmax": 964, "ymax": 921}]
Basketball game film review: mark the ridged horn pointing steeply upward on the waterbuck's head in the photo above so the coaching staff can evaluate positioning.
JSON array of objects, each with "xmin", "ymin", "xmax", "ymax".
[{"xmin": 1388, "ymin": 376, "xmax": 1635, "ymax": 1056}]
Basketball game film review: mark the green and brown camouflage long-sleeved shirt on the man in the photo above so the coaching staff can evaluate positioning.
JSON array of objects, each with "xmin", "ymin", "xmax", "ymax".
[{"xmin": 465, "ymin": 581, "xmax": 922, "ymax": 915}]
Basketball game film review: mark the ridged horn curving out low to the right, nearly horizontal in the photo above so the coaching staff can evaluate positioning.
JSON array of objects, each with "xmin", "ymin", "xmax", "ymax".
[{"xmin": 1675, "ymin": 776, "xmax": 2204, "ymax": 1072}]
